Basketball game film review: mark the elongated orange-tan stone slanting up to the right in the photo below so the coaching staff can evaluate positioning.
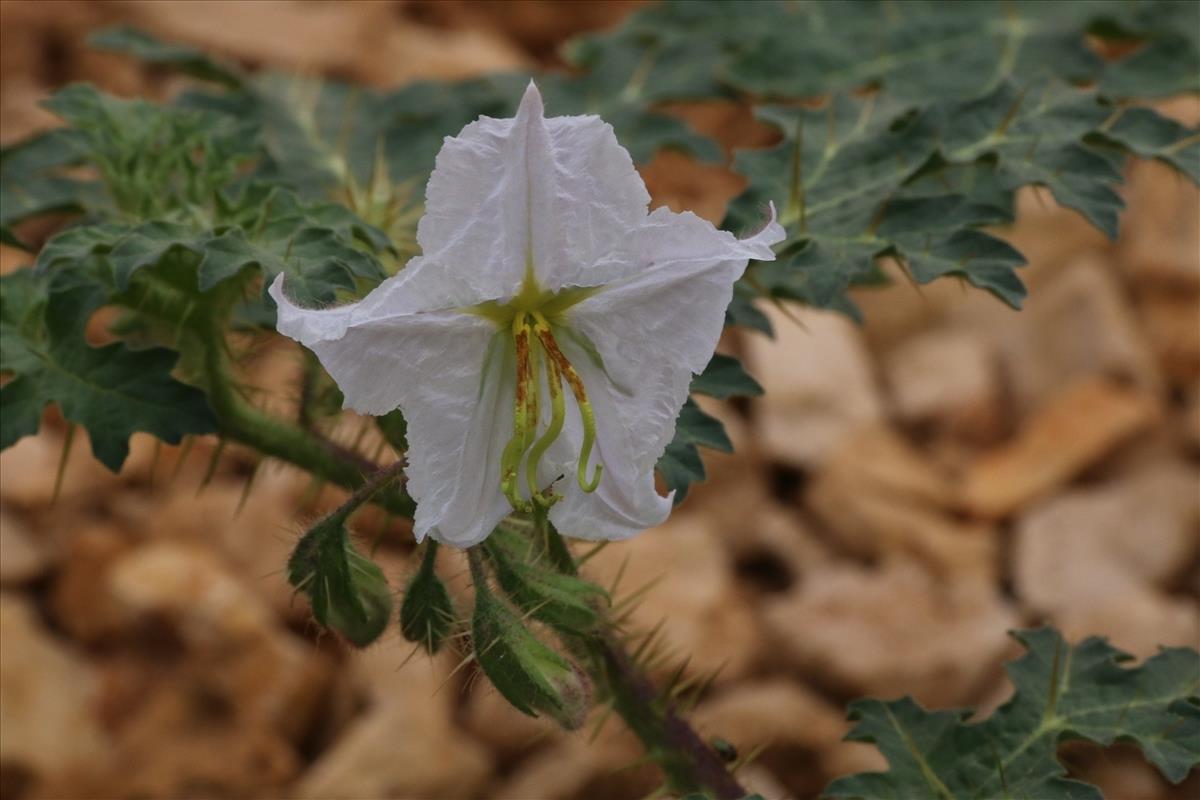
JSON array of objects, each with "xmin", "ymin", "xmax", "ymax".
[{"xmin": 964, "ymin": 378, "xmax": 1160, "ymax": 518}]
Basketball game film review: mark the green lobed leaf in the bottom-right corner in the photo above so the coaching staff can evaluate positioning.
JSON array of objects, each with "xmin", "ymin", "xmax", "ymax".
[{"xmin": 824, "ymin": 628, "xmax": 1200, "ymax": 800}]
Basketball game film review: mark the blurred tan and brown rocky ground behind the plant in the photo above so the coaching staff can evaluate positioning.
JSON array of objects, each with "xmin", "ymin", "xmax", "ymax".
[{"xmin": 0, "ymin": 0, "xmax": 1200, "ymax": 800}]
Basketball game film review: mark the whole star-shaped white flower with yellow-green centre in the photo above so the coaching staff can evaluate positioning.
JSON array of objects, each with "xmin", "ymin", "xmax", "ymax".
[{"xmin": 271, "ymin": 83, "xmax": 784, "ymax": 547}]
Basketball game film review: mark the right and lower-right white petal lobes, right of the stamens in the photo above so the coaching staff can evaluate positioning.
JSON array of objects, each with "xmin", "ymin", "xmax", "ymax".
[{"xmin": 551, "ymin": 207, "xmax": 785, "ymax": 539}]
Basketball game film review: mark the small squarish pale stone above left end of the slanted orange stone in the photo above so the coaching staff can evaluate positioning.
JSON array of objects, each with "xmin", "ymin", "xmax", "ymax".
[{"xmin": 886, "ymin": 329, "xmax": 1006, "ymax": 443}]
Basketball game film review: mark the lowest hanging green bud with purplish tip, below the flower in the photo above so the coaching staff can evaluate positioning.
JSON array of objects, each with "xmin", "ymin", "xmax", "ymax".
[{"xmin": 472, "ymin": 567, "xmax": 592, "ymax": 730}]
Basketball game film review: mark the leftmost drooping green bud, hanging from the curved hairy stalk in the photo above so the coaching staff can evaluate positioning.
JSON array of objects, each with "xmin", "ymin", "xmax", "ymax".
[{"xmin": 288, "ymin": 512, "xmax": 392, "ymax": 648}]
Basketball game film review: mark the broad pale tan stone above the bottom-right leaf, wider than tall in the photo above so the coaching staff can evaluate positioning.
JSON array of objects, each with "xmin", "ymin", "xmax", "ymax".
[{"xmin": 766, "ymin": 561, "xmax": 1018, "ymax": 706}]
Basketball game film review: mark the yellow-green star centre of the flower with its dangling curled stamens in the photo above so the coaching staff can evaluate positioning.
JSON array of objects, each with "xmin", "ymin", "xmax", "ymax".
[{"xmin": 467, "ymin": 269, "xmax": 604, "ymax": 511}]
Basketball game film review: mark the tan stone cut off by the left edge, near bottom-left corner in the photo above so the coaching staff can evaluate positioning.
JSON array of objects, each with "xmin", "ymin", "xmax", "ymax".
[{"xmin": 0, "ymin": 594, "xmax": 110, "ymax": 778}]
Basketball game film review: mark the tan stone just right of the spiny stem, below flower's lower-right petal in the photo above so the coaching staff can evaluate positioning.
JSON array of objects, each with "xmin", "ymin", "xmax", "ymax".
[{"xmin": 583, "ymin": 513, "xmax": 760, "ymax": 681}]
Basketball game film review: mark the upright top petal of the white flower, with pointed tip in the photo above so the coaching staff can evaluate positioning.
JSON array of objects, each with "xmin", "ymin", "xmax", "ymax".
[{"xmin": 416, "ymin": 82, "xmax": 649, "ymax": 302}]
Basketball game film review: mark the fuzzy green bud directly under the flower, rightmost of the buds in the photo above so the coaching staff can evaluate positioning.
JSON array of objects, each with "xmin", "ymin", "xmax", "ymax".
[{"xmin": 484, "ymin": 528, "xmax": 611, "ymax": 633}]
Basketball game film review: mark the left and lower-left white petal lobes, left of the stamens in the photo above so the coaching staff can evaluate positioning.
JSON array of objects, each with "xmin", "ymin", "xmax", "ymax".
[{"xmin": 271, "ymin": 276, "xmax": 514, "ymax": 547}]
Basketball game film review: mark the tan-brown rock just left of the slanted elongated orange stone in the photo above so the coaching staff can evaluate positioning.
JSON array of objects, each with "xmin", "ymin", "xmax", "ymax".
[{"xmin": 804, "ymin": 428, "xmax": 996, "ymax": 579}]
